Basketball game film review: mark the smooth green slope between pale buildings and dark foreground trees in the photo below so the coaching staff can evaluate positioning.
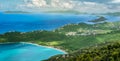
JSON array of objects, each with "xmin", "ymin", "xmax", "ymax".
[{"xmin": 55, "ymin": 31, "xmax": 120, "ymax": 52}]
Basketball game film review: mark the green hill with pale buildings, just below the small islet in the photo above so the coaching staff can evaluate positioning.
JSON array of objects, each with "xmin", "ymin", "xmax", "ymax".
[{"xmin": 55, "ymin": 21, "xmax": 120, "ymax": 35}]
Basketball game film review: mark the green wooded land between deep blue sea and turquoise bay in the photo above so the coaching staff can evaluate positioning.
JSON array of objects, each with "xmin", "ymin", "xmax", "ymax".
[{"xmin": 0, "ymin": 17, "xmax": 120, "ymax": 52}]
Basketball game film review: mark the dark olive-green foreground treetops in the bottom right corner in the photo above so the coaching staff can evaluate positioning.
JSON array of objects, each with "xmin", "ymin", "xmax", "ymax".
[{"xmin": 45, "ymin": 42, "xmax": 120, "ymax": 61}]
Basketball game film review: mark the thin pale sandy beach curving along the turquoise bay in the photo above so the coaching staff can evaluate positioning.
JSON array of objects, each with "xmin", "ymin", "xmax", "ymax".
[{"xmin": 0, "ymin": 42, "xmax": 68, "ymax": 54}]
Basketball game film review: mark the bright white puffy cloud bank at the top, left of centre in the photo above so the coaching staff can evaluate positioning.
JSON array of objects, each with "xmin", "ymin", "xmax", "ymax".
[{"xmin": 20, "ymin": 0, "xmax": 72, "ymax": 8}]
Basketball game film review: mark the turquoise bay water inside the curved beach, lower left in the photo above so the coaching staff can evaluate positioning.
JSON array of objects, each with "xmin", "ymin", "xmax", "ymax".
[{"xmin": 0, "ymin": 43, "xmax": 65, "ymax": 61}]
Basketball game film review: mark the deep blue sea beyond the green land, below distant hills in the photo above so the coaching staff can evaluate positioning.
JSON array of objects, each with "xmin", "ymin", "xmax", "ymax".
[{"xmin": 0, "ymin": 13, "xmax": 120, "ymax": 34}]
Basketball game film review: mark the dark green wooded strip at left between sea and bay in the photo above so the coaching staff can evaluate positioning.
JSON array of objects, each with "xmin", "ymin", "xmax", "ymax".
[{"xmin": 0, "ymin": 31, "xmax": 66, "ymax": 42}]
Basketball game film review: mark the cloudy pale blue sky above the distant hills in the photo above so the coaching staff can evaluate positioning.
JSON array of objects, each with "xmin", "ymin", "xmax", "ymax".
[{"xmin": 0, "ymin": 0, "xmax": 120, "ymax": 13}]
